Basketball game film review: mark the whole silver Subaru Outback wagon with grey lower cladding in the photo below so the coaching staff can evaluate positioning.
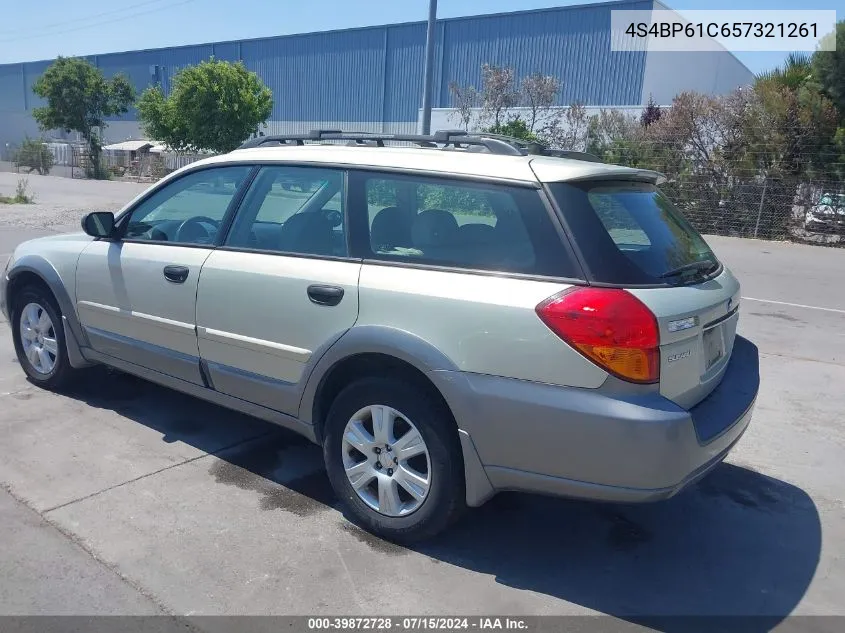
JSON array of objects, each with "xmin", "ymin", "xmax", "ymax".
[{"xmin": 0, "ymin": 132, "xmax": 759, "ymax": 541}]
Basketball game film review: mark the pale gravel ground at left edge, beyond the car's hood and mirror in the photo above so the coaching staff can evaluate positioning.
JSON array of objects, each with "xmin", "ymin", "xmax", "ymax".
[{"xmin": 0, "ymin": 173, "xmax": 150, "ymax": 230}]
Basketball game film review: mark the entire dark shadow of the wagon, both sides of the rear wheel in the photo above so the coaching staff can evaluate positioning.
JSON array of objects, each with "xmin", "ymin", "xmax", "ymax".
[{"xmin": 57, "ymin": 368, "xmax": 821, "ymax": 632}]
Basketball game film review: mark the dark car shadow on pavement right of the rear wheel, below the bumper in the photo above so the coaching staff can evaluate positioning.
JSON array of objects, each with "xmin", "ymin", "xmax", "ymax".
[{"xmin": 420, "ymin": 464, "xmax": 821, "ymax": 631}]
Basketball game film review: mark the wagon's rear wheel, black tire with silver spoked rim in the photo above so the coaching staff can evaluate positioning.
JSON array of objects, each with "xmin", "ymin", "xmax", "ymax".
[{"xmin": 323, "ymin": 378, "xmax": 465, "ymax": 542}]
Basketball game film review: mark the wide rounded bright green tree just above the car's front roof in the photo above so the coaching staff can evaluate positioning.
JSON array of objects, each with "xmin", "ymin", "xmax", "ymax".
[{"xmin": 138, "ymin": 59, "xmax": 273, "ymax": 153}]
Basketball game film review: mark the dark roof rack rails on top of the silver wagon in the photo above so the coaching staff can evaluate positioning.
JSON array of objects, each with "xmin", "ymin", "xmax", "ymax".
[{"xmin": 238, "ymin": 130, "xmax": 602, "ymax": 163}]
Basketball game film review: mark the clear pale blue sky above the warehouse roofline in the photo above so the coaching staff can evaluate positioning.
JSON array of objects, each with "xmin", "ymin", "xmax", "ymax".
[{"xmin": 0, "ymin": 0, "xmax": 845, "ymax": 72}]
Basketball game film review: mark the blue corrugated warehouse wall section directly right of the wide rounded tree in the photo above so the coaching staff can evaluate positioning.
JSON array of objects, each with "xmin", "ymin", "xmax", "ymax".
[{"xmin": 241, "ymin": 28, "xmax": 384, "ymax": 121}]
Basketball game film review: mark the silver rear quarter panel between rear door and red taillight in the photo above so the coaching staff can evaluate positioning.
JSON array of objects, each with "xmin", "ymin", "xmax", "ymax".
[{"xmin": 356, "ymin": 264, "xmax": 608, "ymax": 389}]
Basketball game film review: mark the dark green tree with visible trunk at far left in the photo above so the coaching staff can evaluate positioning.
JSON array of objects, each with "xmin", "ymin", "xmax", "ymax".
[{"xmin": 32, "ymin": 57, "xmax": 135, "ymax": 178}]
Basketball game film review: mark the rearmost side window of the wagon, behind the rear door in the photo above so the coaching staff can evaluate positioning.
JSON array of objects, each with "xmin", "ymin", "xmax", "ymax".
[{"xmin": 357, "ymin": 173, "xmax": 580, "ymax": 278}]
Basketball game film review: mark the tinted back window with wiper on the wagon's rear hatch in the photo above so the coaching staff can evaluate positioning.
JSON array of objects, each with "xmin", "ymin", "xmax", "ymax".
[{"xmin": 549, "ymin": 181, "xmax": 718, "ymax": 285}]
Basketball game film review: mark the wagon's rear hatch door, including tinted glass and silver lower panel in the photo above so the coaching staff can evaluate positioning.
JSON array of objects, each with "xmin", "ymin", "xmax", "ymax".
[{"xmin": 547, "ymin": 176, "xmax": 740, "ymax": 409}]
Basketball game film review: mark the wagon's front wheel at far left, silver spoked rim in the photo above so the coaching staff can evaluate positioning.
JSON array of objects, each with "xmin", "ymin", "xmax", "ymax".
[{"xmin": 10, "ymin": 286, "xmax": 76, "ymax": 390}]
